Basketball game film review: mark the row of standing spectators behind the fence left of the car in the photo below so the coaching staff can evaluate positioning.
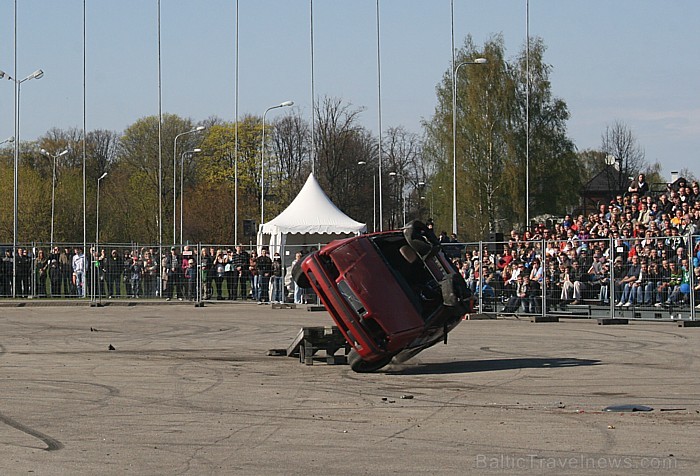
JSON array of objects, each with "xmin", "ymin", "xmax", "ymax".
[{"xmin": 0, "ymin": 245, "xmax": 304, "ymax": 304}]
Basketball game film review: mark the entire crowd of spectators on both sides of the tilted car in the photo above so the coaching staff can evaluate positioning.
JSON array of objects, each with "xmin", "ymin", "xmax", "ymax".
[{"xmin": 0, "ymin": 174, "xmax": 700, "ymax": 313}]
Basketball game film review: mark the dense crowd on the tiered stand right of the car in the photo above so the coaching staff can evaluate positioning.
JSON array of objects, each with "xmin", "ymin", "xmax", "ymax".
[{"xmin": 448, "ymin": 174, "xmax": 700, "ymax": 313}]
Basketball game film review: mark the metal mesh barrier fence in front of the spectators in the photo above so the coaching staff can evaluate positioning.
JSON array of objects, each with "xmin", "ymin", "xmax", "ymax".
[{"xmin": 0, "ymin": 235, "xmax": 700, "ymax": 320}]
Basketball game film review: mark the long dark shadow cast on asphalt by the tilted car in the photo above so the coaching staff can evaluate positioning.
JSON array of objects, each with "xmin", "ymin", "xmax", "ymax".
[{"xmin": 386, "ymin": 358, "xmax": 601, "ymax": 375}]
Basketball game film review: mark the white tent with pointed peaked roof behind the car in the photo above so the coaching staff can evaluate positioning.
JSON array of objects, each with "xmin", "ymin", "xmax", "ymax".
[{"xmin": 258, "ymin": 174, "xmax": 367, "ymax": 254}]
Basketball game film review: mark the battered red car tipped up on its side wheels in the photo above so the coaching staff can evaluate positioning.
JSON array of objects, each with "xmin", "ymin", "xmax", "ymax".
[{"xmin": 292, "ymin": 221, "xmax": 473, "ymax": 372}]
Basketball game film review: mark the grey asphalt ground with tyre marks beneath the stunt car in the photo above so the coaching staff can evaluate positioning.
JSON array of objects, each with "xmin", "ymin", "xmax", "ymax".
[{"xmin": 0, "ymin": 303, "xmax": 700, "ymax": 475}]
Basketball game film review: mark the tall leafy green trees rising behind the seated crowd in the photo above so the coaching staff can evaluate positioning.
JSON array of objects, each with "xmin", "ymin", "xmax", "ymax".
[{"xmin": 424, "ymin": 35, "xmax": 580, "ymax": 239}]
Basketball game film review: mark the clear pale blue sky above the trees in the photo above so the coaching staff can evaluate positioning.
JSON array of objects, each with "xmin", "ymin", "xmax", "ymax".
[{"xmin": 0, "ymin": 0, "xmax": 700, "ymax": 177}]
